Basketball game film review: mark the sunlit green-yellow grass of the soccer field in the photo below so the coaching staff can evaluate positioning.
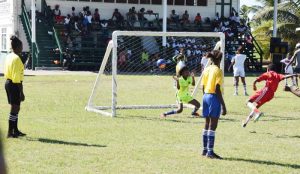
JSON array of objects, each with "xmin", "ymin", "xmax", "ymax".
[{"xmin": 0, "ymin": 75, "xmax": 300, "ymax": 174}]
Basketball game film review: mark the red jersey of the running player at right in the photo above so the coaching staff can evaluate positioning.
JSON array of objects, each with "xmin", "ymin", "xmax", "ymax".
[{"xmin": 257, "ymin": 71, "xmax": 285, "ymax": 93}]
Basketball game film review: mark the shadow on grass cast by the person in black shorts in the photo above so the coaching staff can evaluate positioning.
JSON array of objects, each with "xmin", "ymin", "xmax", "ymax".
[{"xmin": 26, "ymin": 137, "xmax": 107, "ymax": 147}]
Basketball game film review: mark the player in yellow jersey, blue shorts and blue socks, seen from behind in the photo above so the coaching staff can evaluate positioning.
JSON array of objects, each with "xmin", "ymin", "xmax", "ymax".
[{"xmin": 201, "ymin": 50, "xmax": 227, "ymax": 159}]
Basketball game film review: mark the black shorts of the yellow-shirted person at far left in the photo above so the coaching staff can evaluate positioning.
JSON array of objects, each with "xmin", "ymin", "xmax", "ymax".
[{"xmin": 5, "ymin": 79, "xmax": 21, "ymax": 105}]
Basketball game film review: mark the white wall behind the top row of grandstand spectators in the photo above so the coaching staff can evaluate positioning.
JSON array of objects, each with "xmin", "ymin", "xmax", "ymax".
[{"xmin": 42, "ymin": 0, "xmax": 239, "ymax": 20}]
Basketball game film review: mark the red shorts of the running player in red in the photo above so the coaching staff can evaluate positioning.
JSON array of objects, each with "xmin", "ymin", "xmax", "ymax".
[{"xmin": 249, "ymin": 88, "xmax": 274, "ymax": 108}]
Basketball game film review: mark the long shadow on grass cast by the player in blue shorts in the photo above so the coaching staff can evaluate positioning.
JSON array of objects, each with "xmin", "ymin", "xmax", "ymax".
[{"xmin": 224, "ymin": 158, "xmax": 300, "ymax": 169}]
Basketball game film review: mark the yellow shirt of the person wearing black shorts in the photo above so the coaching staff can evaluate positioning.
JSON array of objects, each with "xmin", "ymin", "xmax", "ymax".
[{"xmin": 4, "ymin": 53, "xmax": 24, "ymax": 83}]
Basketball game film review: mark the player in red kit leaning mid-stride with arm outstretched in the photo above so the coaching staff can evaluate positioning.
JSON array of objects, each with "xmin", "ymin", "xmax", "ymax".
[{"xmin": 243, "ymin": 64, "xmax": 298, "ymax": 127}]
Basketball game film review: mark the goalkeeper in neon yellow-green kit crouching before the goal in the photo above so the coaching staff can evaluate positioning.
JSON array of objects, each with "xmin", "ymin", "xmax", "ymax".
[{"xmin": 161, "ymin": 66, "xmax": 200, "ymax": 117}]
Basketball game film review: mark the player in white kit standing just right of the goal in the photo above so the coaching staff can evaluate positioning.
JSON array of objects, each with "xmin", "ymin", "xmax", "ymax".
[{"xmin": 228, "ymin": 47, "xmax": 248, "ymax": 96}]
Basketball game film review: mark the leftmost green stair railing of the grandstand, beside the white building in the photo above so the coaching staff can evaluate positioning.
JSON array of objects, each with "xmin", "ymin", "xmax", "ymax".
[{"xmin": 21, "ymin": 0, "xmax": 40, "ymax": 69}]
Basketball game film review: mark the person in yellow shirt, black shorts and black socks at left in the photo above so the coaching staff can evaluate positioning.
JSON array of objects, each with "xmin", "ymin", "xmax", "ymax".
[{"xmin": 4, "ymin": 36, "xmax": 26, "ymax": 138}]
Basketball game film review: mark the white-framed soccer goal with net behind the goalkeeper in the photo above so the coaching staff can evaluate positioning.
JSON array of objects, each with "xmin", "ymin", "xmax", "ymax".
[{"xmin": 86, "ymin": 31, "xmax": 225, "ymax": 117}]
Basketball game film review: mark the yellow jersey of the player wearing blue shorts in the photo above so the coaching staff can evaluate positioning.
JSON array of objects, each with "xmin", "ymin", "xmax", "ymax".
[{"xmin": 201, "ymin": 65, "xmax": 223, "ymax": 94}]
